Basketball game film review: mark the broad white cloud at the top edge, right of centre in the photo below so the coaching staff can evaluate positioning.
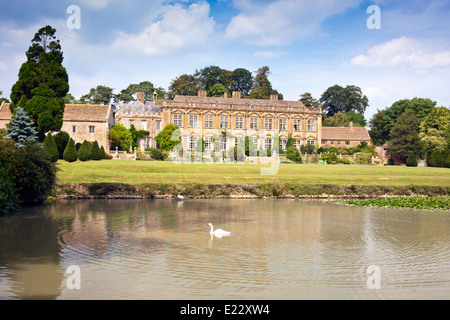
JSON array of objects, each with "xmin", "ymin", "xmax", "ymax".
[{"xmin": 225, "ymin": 0, "xmax": 360, "ymax": 45}]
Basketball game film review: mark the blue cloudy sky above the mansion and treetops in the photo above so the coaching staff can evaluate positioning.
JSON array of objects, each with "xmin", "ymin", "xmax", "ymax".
[{"xmin": 0, "ymin": 0, "xmax": 450, "ymax": 120}]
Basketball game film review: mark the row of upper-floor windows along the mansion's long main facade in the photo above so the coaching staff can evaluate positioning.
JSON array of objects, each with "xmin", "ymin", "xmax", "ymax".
[{"xmin": 173, "ymin": 114, "xmax": 315, "ymax": 132}]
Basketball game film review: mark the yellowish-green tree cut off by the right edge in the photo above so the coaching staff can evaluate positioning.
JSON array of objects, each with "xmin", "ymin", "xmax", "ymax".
[{"xmin": 419, "ymin": 107, "xmax": 450, "ymax": 150}]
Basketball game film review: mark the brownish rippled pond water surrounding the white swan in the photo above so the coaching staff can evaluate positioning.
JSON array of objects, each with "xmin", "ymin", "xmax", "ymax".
[{"xmin": 0, "ymin": 199, "xmax": 450, "ymax": 300}]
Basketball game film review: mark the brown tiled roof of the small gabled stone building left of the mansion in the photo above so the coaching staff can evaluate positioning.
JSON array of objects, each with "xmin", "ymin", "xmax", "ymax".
[{"xmin": 63, "ymin": 104, "xmax": 111, "ymax": 122}]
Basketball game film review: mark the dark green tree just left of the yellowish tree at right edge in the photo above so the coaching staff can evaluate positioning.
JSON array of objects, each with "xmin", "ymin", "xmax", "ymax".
[{"xmin": 388, "ymin": 109, "xmax": 422, "ymax": 161}]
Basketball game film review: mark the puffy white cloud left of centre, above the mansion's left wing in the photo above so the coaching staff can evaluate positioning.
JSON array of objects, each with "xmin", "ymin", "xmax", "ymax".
[{"xmin": 113, "ymin": 2, "xmax": 215, "ymax": 56}]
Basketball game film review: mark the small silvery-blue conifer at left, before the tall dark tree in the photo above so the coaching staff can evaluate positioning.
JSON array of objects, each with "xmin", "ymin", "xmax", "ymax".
[{"xmin": 4, "ymin": 107, "xmax": 37, "ymax": 148}]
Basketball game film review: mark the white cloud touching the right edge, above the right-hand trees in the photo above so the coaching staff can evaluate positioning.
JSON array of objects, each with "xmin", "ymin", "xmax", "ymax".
[{"xmin": 347, "ymin": 37, "xmax": 450, "ymax": 70}]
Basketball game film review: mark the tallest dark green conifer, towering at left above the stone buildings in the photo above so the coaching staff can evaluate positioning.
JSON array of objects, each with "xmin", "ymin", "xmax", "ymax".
[{"xmin": 10, "ymin": 26, "xmax": 69, "ymax": 141}]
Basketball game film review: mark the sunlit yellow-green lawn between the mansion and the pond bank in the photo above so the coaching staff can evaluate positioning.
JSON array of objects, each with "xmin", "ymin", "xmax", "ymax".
[{"xmin": 57, "ymin": 160, "xmax": 450, "ymax": 186}]
